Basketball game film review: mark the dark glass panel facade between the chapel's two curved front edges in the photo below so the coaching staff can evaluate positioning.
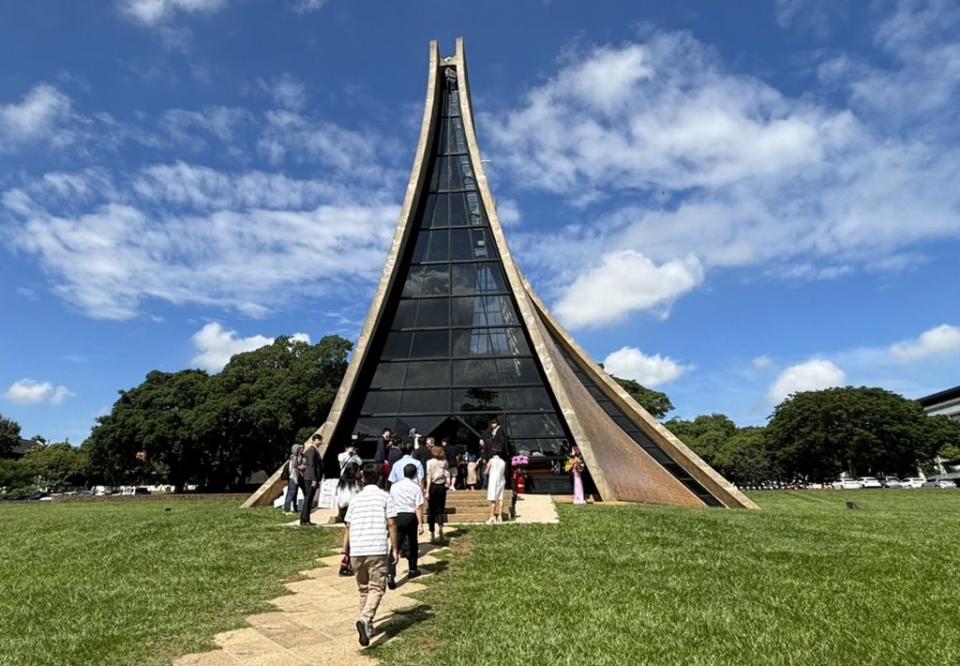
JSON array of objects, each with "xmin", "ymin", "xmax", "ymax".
[{"xmin": 335, "ymin": 67, "xmax": 570, "ymax": 457}]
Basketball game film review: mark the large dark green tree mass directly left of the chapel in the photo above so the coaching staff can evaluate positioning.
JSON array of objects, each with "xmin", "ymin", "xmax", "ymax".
[{"xmin": 84, "ymin": 336, "xmax": 351, "ymax": 490}]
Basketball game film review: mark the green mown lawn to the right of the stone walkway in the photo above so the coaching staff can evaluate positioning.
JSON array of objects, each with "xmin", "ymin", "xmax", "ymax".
[{"xmin": 375, "ymin": 490, "xmax": 960, "ymax": 666}]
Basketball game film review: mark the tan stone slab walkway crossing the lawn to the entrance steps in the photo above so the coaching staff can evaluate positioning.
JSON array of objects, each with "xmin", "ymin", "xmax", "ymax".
[{"xmin": 173, "ymin": 531, "xmax": 455, "ymax": 666}]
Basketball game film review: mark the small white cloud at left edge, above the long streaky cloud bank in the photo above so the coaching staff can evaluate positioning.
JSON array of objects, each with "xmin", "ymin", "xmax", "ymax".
[{"xmin": 0, "ymin": 83, "xmax": 71, "ymax": 150}]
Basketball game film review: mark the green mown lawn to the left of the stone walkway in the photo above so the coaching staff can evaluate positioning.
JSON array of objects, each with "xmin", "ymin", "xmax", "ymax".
[{"xmin": 0, "ymin": 500, "xmax": 338, "ymax": 665}]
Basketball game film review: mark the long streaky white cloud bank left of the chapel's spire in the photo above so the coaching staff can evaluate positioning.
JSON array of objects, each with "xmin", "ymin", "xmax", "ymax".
[{"xmin": 0, "ymin": 163, "xmax": 398, "ymax": 319}]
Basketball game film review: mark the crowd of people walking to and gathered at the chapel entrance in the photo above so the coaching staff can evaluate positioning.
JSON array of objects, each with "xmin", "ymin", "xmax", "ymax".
[{"xmin": 282, "ymin": 419, "xmax": 507, "ymax": 646}]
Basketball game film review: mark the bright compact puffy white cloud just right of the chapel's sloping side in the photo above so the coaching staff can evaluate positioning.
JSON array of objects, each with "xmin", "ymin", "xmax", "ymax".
[{"xmin": 555, "ymin": 250, "xmax": 703, "ymax": 328}]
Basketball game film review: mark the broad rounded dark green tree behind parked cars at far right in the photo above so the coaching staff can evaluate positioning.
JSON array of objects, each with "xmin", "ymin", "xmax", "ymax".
[{"xmin": 767, "ymin": 387, "xmax": 949, "ymax": 481}]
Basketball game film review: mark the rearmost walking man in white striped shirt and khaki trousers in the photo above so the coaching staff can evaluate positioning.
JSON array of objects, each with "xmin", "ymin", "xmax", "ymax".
[{"xmin": 343, "ymin": 463, "xmax": 399, "ymax": 647}]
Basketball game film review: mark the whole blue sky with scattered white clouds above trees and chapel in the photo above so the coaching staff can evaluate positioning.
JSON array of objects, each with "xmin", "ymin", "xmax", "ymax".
[{"xmin": 0, "ymin": 0, "xmax": 960, "ymax": 442}]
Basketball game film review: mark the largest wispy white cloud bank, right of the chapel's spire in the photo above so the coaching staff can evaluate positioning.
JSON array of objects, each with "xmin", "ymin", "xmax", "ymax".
[{"xmin": 498, "ymin": 24, "xmax": 960, "ymax": 321}]
